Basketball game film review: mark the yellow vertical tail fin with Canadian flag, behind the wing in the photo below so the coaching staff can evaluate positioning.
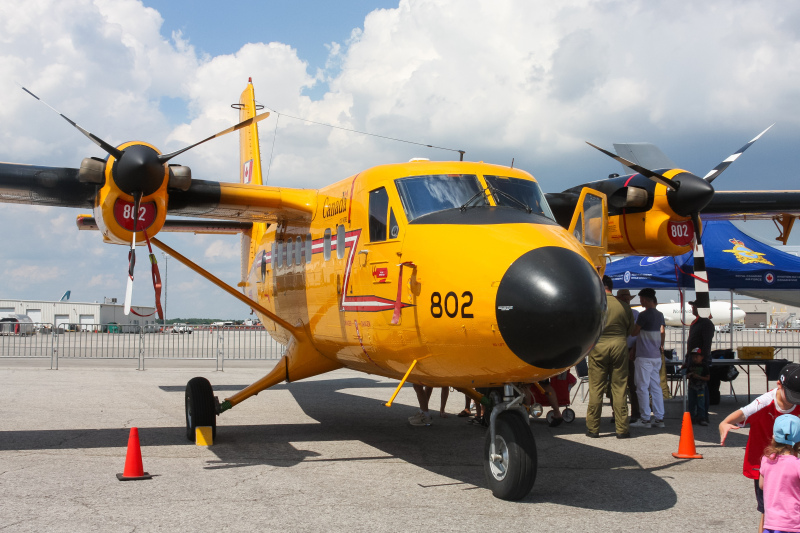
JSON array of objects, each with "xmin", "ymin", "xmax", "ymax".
[{"xmin": 238, "ymin": 78, "xmax": 267, "ymax": 281}]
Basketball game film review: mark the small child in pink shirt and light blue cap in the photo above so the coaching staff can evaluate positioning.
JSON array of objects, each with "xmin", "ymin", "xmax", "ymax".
[{"xmin": 758, "ymin": 415, "xmax": 800, "ymax": 533}]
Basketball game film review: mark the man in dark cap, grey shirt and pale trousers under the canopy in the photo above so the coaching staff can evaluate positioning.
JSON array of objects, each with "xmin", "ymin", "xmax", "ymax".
[{"xmin": 631, "ymin": 288, "xmax": 666, "ymax": 428}]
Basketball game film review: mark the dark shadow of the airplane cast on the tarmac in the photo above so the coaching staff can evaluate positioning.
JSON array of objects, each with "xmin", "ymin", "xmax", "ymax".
[{"xmin": 0, "ymin": 378, "xmax": 684, "ymax": 512}]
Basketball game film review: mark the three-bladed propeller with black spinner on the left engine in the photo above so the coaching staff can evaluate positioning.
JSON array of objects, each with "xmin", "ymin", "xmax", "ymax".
[{"xmin": 20, "ymin": 85, "xmax": 269, "ymax": 315}]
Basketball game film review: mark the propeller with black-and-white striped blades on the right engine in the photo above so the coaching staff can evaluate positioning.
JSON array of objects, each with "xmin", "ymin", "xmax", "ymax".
[{"xmin": 586, "ymin": 124, "xmax": 774, "ymax": 318}]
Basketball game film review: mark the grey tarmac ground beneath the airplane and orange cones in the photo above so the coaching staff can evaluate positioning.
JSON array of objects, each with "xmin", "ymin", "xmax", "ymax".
[{"xmin": 0, "ymin": 360, "xmax": 774, "ymax": 533}]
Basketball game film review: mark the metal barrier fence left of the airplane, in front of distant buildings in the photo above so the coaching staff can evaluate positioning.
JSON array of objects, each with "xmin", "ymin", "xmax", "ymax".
[{"xmin": 0, "ymin": 324, "xmax": 285, "ymax": 370}]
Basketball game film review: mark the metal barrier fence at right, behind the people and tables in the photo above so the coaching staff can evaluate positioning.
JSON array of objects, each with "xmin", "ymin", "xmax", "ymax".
[{"xmin": 664, "ymin": 327, "xmax": 800, "ymax": 363}]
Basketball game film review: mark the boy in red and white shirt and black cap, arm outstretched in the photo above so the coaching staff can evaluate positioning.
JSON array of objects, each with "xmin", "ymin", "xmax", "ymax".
[{"xmin": 719, "ymin": 363, "xmax": 800, "ymax": 531}]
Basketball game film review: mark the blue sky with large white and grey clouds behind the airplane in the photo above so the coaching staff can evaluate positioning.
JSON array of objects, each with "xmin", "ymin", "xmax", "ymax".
[{"xmin": 0, "ymin": 0, "xmax": 800, "ymax": 318}]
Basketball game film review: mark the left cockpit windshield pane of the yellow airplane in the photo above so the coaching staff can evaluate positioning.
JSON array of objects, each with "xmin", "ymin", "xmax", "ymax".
[{"xmin": 395, "ymin": 174, "xmax": 488, "ymax": 222}]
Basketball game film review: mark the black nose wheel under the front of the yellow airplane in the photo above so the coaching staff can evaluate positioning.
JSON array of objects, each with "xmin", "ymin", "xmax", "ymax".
[{"xmin": 483, "ymin": 412, "xmax": 537, "ymax": 500}]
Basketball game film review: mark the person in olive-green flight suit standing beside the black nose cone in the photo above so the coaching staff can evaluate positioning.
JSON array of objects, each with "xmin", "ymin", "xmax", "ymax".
[{"xmin": 586, "ymin": 276, "xmax": 634, "ymax": 439}]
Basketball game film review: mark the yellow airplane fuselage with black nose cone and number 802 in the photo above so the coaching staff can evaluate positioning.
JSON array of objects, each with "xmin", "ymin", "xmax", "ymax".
[{"xmin": 245, "ymin": 162, "xmax": 606, "ymax": 387}]
